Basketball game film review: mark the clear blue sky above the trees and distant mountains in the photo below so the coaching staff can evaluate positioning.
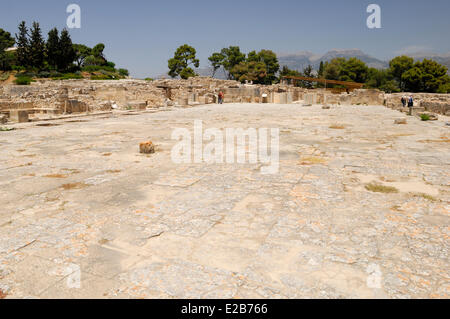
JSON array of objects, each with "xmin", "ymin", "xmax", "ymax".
[{"xmin": 0, "ymin": 0, "xmax": 450, "ymax": 77}]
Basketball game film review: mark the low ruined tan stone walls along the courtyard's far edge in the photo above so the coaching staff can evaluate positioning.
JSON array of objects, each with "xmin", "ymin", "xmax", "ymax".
[{"xmin": 0, "ymin": 77, "xmax": 450, "ymax": 120}]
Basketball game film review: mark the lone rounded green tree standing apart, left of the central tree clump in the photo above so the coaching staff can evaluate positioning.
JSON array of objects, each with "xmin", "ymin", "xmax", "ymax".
[{"xmin": 168, "ymin": 44, "xmax": 200, "ymax": 79}]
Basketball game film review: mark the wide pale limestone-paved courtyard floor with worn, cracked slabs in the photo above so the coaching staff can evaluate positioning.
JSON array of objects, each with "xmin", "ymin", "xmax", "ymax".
[{"xmin": 0, "ymin": 104, "xmax": 450, "ymax": 298}]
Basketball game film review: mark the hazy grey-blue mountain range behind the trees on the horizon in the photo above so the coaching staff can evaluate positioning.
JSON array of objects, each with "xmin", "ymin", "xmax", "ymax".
[{"xmin": 185, "ymin": 49, "xmax": 450, "ymax": 79}]
